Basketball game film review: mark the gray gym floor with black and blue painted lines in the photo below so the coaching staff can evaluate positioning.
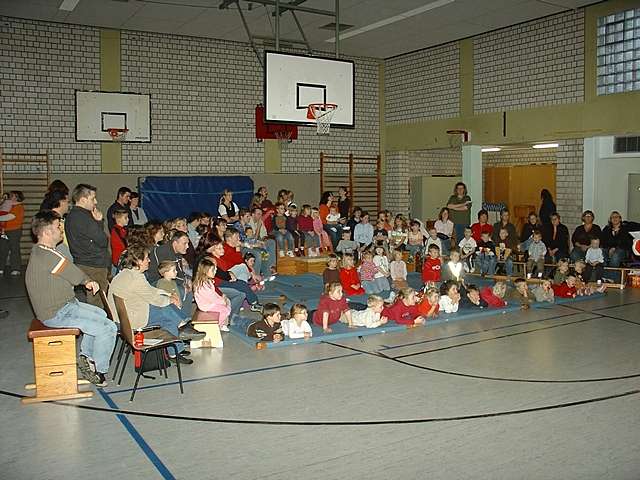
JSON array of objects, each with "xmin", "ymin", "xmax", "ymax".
[{"xmin": 0, "ymin": 278, "xmax": 640, "ymax": 479}]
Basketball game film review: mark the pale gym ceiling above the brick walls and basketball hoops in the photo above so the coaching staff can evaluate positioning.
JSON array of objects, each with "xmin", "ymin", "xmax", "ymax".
[{"xmin": 0, "ymin": 0, "xmax": 599, "ymax": 58}]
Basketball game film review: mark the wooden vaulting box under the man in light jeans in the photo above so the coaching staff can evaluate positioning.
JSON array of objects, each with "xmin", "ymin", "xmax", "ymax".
[{"xmin": 22, "ymin": 319, "xmax": 93, "ymax": 404}]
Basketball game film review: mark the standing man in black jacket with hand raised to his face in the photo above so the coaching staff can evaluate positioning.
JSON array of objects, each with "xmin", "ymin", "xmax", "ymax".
[{"xmin": 64, "ymin": 183, "xmax": 111, "ymax": 307}]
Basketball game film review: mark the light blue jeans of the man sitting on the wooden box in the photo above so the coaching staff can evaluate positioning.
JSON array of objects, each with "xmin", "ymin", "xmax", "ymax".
[{"xmin": 42, "ymin": 299, "xmax": 118, "ymax": 373}]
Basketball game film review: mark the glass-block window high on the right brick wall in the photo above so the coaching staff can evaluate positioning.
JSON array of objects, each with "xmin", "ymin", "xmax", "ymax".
[{"xmin": 597, "ymin": 8, "xmax": 640, "ymax": 95}]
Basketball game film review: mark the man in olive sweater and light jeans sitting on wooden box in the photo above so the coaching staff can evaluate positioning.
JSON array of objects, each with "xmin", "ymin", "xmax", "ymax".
[{"xmin": 25, "ymin": 210, "xmax": 118, "ymax": 387}]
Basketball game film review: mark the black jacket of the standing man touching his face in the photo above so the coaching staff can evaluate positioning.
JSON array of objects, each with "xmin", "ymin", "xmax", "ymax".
[{"xmin": 64, "ymin": 205, "xmax": 111, "ymax": 268}]
